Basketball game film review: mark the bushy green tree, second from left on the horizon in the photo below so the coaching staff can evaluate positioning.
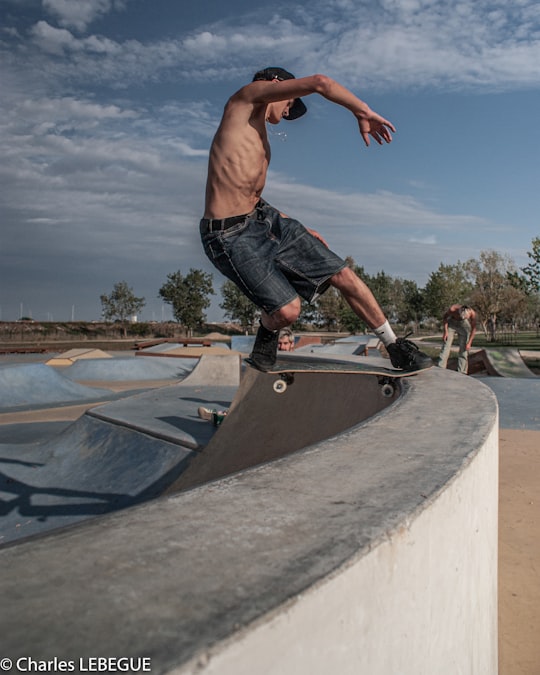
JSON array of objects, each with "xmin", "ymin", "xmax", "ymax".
[{"xmin": 159, "ymin": 268, "xmax": 214, "ymax": 335}]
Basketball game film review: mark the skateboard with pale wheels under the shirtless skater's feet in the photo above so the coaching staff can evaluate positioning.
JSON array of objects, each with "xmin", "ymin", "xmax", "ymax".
[{"xmin": 245, "ymin": 354, "xmax": 431, "ymax": 398}]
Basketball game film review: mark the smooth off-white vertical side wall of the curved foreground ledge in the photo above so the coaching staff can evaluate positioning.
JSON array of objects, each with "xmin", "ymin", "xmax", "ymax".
[{"xmin": 178, "ymin": 424, "xmax": 498, "ymax": 675}]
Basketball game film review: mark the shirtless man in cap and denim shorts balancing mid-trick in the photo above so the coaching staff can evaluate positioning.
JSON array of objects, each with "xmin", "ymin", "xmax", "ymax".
[{"xmin": 200, "ymin": 68, "xmax": 432, "ymax": 371}]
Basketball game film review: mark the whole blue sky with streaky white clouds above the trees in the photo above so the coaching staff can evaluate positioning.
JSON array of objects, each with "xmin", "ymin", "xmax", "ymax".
[{"xmin": 0, "ymin": 0, "xmax": 540, "ymax": 321}]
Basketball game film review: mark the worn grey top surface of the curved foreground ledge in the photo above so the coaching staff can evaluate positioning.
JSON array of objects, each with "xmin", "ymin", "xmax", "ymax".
[{"xmin": 0, "ymin": 368, "xmax": 497, "ymax": 673}]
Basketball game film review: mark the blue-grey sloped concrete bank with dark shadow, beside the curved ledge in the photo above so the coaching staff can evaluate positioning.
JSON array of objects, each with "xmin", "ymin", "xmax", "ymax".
[{"xmin": 0, "ymin": 414, "xmax": 194, "ymax": 544}]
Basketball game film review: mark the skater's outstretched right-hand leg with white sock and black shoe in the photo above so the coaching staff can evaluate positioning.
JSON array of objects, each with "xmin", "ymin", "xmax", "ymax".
[{"xmin": 330, "ymin": 267, "xmax": 433, "ymax": 371}]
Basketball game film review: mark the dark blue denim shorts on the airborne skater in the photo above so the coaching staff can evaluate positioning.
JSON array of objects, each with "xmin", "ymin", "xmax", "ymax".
[{"xmin": 200, "ymin": 199, "xmax": 346, "ymax": 314}]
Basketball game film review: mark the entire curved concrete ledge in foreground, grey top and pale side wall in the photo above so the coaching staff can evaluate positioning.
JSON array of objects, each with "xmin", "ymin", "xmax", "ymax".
[{"xmin": 0, "ymin": 369, "xmax": 498, "ymax": 675}]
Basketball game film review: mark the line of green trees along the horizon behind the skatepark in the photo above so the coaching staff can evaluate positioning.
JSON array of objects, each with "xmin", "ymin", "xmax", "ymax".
[{"xmin": 100, "ymin": 237, "xmax": 540, "ymax": 339}]
